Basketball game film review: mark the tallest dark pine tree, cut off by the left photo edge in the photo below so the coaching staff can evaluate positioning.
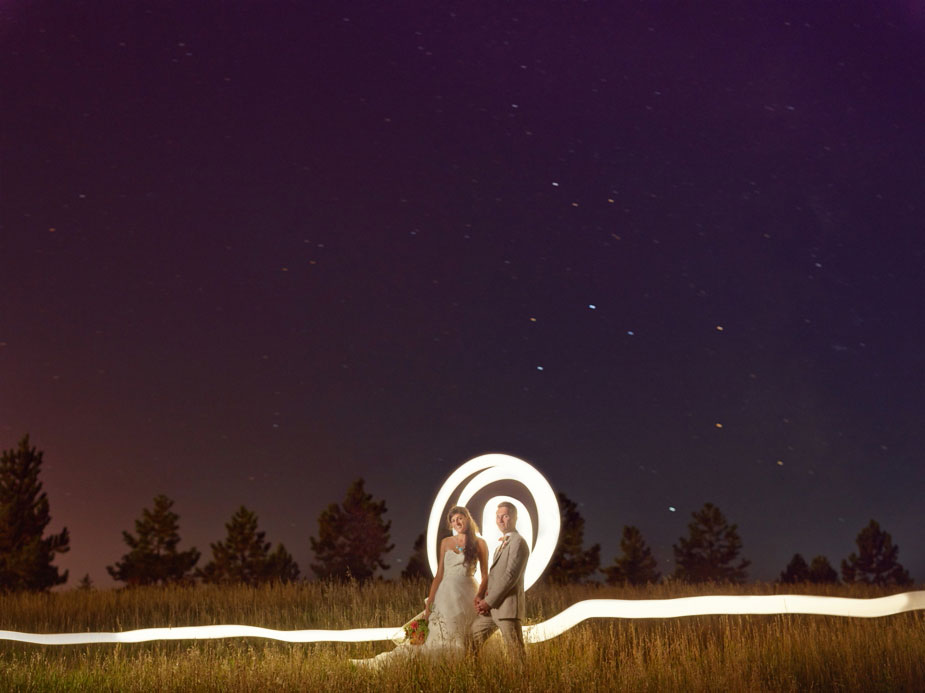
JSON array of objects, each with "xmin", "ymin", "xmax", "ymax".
[{"xmin": 0, "ymin": 435, "xmax": 70, "ymax": 591}]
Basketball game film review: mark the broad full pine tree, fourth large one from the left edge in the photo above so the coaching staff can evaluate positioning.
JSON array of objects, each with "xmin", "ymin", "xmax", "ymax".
[{"xmin": 311, "ymin": 479, "xmax": 395, "ymax": 582}]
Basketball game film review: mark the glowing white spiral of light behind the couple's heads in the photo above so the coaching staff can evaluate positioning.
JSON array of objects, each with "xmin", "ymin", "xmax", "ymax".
[{"xmin": 427, "ymin": 453, "xmax": 561, "ymax": 589}]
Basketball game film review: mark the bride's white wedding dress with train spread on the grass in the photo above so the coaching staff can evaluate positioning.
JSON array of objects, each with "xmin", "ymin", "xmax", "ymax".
[{"xmin": 351, "ymin": 551, "xmax": 478, "ymax": 668}]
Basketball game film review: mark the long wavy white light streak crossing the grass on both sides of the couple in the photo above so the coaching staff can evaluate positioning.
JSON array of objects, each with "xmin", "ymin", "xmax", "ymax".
[{"xmin": 0, "ymin": 591, "xmax": 925, "ymax": 645}]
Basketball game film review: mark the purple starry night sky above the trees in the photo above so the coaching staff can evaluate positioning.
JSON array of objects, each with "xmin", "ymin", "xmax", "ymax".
[{"xmin": 0, "ymin": 0, "xmax": 925, "ymax": 586}]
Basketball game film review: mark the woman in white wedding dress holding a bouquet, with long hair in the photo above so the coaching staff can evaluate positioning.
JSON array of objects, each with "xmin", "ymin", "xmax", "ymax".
[{"xmin": 352, "ymin": 505, "xmax": 488, "ymax": 668}]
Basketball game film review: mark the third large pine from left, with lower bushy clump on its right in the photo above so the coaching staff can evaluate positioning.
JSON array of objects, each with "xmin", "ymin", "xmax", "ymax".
[{"xmin": 198, "ymin": 505, "xmax": 299, "ymax": 585}]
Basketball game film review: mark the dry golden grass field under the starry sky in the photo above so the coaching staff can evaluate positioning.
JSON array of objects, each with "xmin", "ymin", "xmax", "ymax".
[{"xmin": 0, "ymin": 582, "xmax": 925, "ymax": 691}]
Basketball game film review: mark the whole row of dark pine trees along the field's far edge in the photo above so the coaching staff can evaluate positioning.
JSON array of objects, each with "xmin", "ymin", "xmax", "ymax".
[{"xmin": 0, "ymin": 435, "xmax": 912, "ymax": 591}]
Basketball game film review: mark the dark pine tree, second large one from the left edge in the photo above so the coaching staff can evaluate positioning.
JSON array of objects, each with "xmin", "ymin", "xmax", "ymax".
[{"xmin": 106, "ymin": 494, "xmax": 200, "ymax": 587}]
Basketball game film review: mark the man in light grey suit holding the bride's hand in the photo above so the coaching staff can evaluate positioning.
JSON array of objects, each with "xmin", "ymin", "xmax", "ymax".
[{"xmin": 472, "ymin": 501, "xmax": 530, "ymax": 661}]
